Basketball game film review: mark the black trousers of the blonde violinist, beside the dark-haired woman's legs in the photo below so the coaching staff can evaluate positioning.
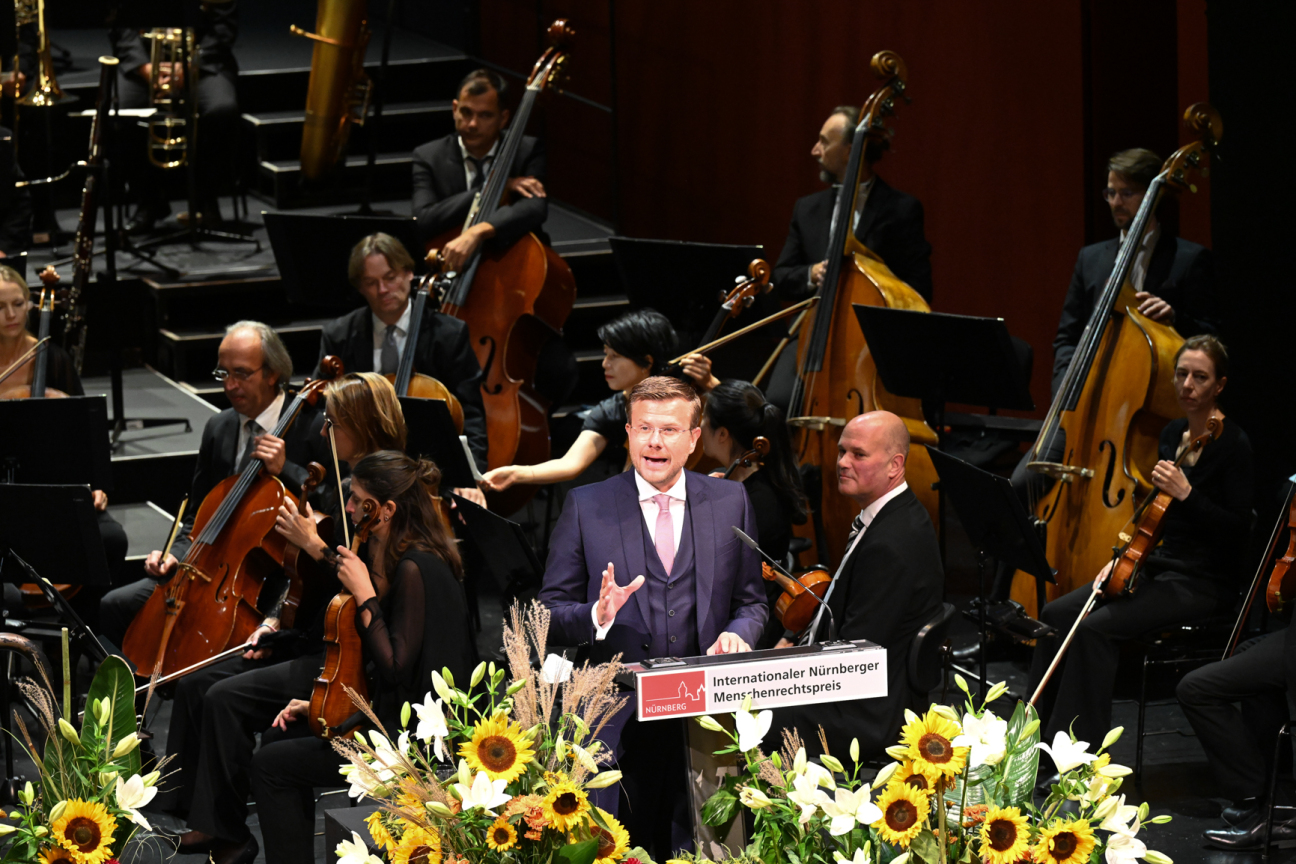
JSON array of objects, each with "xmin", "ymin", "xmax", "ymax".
[{"xmin": 177, "ymin": 654, "xmax": 324, "ymax": 839}]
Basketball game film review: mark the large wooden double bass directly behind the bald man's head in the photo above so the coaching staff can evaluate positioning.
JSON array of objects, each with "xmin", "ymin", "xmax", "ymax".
[{"xmin": 788, "ymin": 51, "xmax": 940, "ymax": 565}]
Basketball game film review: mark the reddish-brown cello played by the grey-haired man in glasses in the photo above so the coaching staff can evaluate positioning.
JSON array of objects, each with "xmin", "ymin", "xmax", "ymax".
[{"xmin": 122, "ymin": 356, "xmax": 342, "ymax": 676}]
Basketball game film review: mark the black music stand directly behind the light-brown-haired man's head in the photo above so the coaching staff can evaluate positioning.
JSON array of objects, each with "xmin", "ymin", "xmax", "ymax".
[{"xmin": 260, "ymin": 211, "xmax": 422, "ymax": 312}]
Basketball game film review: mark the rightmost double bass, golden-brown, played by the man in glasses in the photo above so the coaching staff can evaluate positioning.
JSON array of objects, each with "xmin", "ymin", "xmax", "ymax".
[{"xmin": 1012, "ymin": 102, "xmax": 1222, "ymax": 615}]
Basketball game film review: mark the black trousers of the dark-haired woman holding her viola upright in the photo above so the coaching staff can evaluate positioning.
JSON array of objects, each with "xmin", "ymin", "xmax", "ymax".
[{"xmin": 250, "ymin": 723, "xmax": 346, "ymax": 864}]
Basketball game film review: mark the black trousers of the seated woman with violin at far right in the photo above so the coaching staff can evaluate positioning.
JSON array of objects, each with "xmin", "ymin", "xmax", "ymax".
[{"xmin": 1030, "ymin": 573, "xmax": 1217, "ymax": 746}]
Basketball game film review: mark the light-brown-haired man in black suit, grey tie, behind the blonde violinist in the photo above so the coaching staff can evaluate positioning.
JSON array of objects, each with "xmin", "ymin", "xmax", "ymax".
[{"xmin": 316, "ymin": 233, "xmax": 487, "ymax": 506}]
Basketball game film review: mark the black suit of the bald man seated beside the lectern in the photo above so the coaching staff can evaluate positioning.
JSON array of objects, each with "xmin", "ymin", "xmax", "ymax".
[{"xmin": 771, "ymin": 490, "xmax": 945, "ymax": 760}]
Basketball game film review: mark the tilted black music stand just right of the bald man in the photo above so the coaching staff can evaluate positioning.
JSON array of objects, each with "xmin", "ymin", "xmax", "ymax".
[{"xmin": 931, "ymin": 449, "xmax": 1058, "ymax": 698}]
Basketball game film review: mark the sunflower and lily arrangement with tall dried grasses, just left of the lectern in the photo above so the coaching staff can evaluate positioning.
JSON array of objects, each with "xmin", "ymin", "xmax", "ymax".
[{"xmin": 334, "ymin": 604, "xmax": 630, "ymax": 864}]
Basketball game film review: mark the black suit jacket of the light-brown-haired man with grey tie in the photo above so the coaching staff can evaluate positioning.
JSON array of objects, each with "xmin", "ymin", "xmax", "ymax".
[{"xmin": 315, "ymin": 306, "xmax": 489, "ymax": 466}]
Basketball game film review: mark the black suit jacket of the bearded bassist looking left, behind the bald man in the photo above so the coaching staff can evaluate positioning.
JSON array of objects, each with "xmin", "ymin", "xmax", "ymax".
[{"xmin": 774, "ymin": 177, "xmax": 932, "ymax": 303}]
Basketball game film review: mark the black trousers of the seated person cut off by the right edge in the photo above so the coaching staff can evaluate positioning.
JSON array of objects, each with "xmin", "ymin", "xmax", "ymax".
[{"xmin": 1177, "ymin": 627, "xmax": 1296, "ymax": 801}]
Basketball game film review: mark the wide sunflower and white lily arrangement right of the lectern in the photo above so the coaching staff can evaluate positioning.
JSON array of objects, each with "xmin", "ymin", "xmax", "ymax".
[{"xmin": 699, "ymin": 676, "xmax": 1173, "ymax": 864}]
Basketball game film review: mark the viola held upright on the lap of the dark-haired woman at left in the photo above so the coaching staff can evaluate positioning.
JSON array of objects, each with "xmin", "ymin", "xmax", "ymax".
[{"xmin": 306, "ymin": 499, "xmax": 378, "ymax": 738}]
